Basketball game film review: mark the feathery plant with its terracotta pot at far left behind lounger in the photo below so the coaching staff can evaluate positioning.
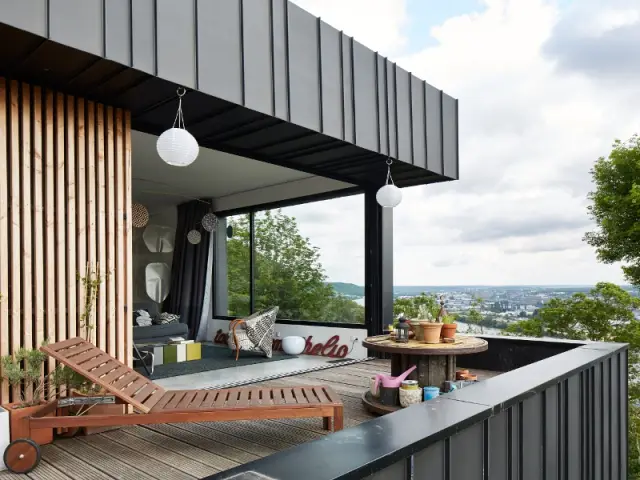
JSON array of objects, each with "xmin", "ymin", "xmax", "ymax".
[{"xmin": 1, "ymin": 348, "xmax": 53, "ymax": 445}]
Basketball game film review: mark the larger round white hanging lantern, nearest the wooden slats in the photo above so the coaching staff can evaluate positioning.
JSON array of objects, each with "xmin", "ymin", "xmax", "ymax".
[{"xmin": 156, "ymin": 88, "xmax": 200, "ymax": 167}]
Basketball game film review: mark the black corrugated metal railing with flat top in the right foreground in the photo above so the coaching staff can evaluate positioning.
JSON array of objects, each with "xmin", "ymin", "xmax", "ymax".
[{"xmin": 209, "ymin": 343, "xmax": 628, "ymax": 480}]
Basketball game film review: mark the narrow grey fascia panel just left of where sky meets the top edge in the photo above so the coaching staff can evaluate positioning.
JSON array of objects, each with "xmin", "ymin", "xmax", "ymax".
[{"xmin": 271, "ymin": 0, "xmax": 289, "ymax": 120}]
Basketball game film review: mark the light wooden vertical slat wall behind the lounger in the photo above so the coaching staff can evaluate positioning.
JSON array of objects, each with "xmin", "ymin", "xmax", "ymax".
[{"xmin": 0, "ymin": 78, "xmax": 132, "ymax": 403}]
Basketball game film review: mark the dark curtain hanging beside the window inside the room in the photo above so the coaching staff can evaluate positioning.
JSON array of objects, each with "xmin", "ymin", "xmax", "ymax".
[{"xmin": 164, "ymin": 200, "xmax": 211, "ymax": 339}]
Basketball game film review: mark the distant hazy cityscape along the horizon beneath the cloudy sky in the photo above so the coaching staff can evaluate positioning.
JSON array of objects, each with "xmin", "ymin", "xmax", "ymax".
[{"xmin": 331, "ymin": 282, "xmax": 640, "ymax": 330}]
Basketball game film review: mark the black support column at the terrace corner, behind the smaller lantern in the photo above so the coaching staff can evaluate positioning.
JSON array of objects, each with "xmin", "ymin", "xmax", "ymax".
[{"xmin": 364, "ymin": 190, "xmax": 393, "ymax": 335}]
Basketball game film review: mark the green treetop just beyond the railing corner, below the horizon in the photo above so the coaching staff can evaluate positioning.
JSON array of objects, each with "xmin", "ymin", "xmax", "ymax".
[{"xmin": 504, "ymin": 283, "xmax": 640, "ymax": 478}]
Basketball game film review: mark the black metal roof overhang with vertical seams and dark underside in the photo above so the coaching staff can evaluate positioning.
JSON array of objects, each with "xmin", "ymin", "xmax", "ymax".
[{"xmin": 0, "ymin": 0, "xmax": 458, "ymax": 191}]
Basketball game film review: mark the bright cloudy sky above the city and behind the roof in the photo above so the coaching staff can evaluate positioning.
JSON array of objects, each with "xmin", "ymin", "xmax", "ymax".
[{"xmin": 286, "ymin": 0, "xmax": 640, "ymax": 285}]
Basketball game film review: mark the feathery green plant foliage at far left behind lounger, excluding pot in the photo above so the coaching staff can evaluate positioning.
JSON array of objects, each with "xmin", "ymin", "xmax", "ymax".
[{"xmin": 0, "ymin": 341, "xmax": 47, "ymax": 407}]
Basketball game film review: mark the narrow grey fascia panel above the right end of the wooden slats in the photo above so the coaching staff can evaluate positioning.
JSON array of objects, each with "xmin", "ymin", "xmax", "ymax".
[{"xmin": 104, "ymin": 0, "xmax": 135, "ymax": 66}]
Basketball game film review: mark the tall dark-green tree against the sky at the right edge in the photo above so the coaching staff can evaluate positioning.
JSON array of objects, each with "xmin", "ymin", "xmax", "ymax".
[{"xmin": 585, "ymin": 135, "xmax": 640, "ymax": 285}]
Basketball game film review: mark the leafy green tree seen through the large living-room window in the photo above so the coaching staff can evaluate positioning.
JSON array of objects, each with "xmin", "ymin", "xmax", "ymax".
[{"xmin": 227, "ymin": 210, "xmax": 364, "ymax": 323}]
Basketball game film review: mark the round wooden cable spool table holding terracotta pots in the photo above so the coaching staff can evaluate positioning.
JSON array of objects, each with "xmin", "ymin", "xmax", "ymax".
[{"xmin": 362, "ymin": 335, "xmax": 488, "ymax": 414}]
